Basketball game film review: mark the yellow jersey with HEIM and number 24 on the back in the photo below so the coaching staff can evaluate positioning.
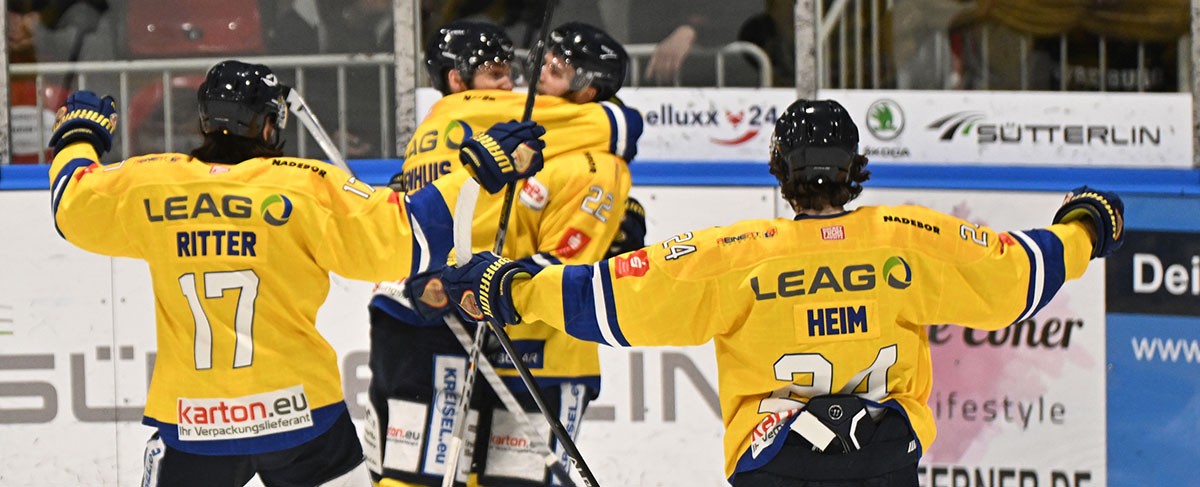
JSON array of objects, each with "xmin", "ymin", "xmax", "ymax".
[{"xmin": 512, "ymin": 206, "xmax": 1092, "ymax": 477}]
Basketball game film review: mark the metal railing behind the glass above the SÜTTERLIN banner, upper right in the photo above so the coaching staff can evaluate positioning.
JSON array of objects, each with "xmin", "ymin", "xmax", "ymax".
[{"xmin": 815, "ymin": 0, "xmax": 1192, "ymax": 91}]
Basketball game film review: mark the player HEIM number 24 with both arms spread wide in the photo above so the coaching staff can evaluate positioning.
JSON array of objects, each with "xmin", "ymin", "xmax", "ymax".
[{"xmin": 443, "ymin": 100, "xmax": 1123, "ymax": 486}]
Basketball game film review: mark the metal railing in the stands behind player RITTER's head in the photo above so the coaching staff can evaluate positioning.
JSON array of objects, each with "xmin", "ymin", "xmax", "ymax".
[{"xmin": 8, "ymin": 53, "xmax": 395, "ymax": 163}]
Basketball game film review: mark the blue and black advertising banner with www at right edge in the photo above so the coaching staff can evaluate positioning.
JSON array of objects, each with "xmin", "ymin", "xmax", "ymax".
[{"xmin": 1105, "ymin": 197, "xmax": 1200, "ymax": 486}]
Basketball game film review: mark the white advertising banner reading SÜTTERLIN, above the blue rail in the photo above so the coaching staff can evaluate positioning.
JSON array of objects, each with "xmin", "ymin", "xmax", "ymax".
[{"xmin": 418, "ymin": 88, "xmax": 1192, "ymax": 168}]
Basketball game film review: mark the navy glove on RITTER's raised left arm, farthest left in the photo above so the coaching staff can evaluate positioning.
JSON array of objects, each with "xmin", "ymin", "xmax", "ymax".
[{"xmin": 49, "ymin": 90, "xmax": 116, "ymax": 155}]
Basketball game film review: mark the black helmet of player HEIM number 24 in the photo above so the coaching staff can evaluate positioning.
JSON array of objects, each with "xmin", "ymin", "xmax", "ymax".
[{"xmin": 770, "ymin": 100, "xmax": 858, "ymax": 184}]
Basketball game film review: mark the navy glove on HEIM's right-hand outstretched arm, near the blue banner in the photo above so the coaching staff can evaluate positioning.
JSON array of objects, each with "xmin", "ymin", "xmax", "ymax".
[{"xmin": 1054, "ymin": 186, "xmax": 1124, "ymax": 259}]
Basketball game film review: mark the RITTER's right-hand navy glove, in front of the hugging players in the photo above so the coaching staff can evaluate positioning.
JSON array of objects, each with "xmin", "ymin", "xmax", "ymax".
[{"xmin": 458, "ymin": 120, "xmax": 546, "ymax": 194}]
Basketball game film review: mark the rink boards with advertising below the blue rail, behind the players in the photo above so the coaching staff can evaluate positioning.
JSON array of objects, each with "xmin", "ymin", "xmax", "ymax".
[{"xmin": 0, "ymin": 172, "xmax": 1200, "ymax": 486}]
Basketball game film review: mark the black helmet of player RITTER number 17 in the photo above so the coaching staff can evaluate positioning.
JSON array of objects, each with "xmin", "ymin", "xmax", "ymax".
[{"xmin": 197, "ymin": 60, "xmax": 288, "ymax": 139}]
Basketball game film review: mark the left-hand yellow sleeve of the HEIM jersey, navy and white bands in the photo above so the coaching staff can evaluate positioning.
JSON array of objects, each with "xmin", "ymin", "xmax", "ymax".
[{"xmin": 512, "ymin": 224, "xmax": 742, "ymax": 347}]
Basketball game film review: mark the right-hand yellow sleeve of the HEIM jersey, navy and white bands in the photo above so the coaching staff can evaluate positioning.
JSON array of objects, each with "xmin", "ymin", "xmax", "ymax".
[{"xmin": 895, "ymin": 208, "xmax": 1092, "ymax": 330}]
